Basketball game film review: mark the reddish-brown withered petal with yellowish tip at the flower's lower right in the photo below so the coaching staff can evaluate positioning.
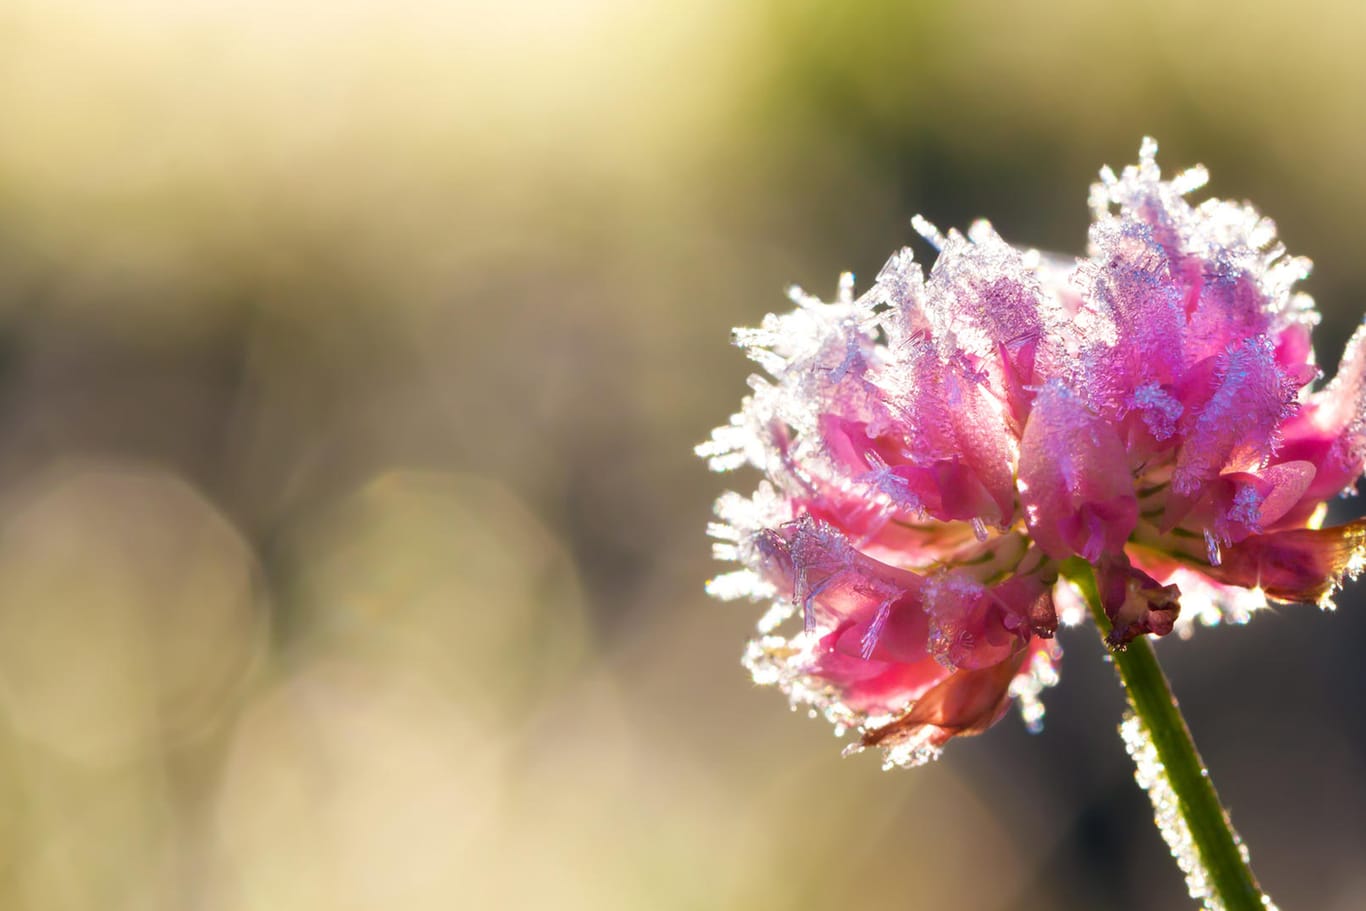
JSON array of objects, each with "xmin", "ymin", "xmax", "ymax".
[{"xmin": 1206, "ymin": 519, "xmax": 1366, "ymax": 608}]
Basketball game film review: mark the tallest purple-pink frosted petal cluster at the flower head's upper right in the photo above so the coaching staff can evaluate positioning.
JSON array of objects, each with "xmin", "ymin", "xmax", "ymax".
[{"xmin": 1072, "ymin": 141, "xmax": 1317, "ymax": 483}]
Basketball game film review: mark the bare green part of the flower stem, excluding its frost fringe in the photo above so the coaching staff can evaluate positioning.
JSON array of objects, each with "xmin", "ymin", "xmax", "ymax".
[{"xmin": 1065, "ymin": 561, "xmax": 1272, "ymax": 911}]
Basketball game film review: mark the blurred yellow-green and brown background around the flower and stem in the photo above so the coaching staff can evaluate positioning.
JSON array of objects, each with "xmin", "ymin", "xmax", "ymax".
[{"xmin": 0, "ymin": 0, "xmax": 1366, "ymax": 911}]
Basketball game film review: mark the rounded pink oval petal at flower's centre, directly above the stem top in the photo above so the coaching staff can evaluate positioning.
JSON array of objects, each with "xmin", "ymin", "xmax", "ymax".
[{"xmin": 1019, "ymin": 380, "xmax": 1138, "ymax": 561}]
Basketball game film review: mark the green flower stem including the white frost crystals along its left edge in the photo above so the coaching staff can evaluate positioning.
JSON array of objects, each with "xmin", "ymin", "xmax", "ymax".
[{"xmin": 1067, "ymin": 564, "xmax": 1274, "ymax": 911}]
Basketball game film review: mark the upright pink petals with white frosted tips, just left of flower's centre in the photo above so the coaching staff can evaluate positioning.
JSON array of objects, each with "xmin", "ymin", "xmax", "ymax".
[{"xmin": 863, "ymin": 223, "xmax": 1065, "ymax": 527}]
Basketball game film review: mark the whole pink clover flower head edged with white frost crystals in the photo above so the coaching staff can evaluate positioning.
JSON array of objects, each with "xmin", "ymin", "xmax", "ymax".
[{"xmin": 698, "ymin": 139, "xmax": 1366, "ymax": 765}]
